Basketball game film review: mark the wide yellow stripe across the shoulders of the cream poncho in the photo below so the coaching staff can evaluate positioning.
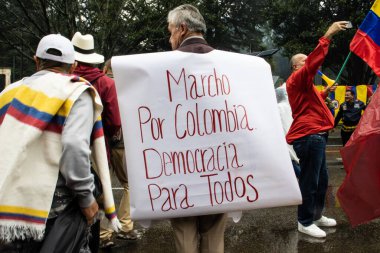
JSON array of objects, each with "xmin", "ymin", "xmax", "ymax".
[{"xmin": 0, "ymin": 85, "xmax": 73, "ymax": 117}]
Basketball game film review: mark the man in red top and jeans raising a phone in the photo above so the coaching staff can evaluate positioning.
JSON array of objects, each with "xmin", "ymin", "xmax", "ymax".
[{"xmin": 286, "ymin": 21, "xmax": 348, "ymax": 237}]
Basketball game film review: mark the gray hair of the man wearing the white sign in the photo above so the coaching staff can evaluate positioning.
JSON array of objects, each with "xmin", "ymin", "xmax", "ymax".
[{"xmin": 168, "ymin": 4, "xmax": 207, "ymax": 34}]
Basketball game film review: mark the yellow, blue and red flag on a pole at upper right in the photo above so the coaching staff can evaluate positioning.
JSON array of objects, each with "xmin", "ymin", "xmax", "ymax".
[{"xmin": 350, "ymin": 0, "xmax": 380, "ymax": 76}]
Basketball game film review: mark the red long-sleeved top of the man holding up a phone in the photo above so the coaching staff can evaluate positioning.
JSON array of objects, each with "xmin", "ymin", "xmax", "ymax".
[{"xmin": 286, "ymin": 37, "xmax": 334, "ymax": 144}]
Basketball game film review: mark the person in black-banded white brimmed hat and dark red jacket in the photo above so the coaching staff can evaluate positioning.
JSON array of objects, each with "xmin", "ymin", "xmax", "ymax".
[{"xmin": 71, "ymin": 32, "xmax": 137, "ymax": 248}]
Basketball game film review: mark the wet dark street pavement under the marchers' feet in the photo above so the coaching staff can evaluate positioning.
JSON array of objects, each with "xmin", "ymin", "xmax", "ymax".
[{"xmin": 101, "ymin": 131, "xmax": 380, "ymax": 253}]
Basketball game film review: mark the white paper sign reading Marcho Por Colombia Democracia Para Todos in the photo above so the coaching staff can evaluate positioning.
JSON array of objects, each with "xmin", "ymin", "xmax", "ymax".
[{"xmin": 112, "ymin": 50, "xmax": 301, "ymax": 220}]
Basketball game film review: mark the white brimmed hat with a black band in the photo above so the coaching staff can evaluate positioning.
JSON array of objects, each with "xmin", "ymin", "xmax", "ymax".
[{"xmin": 71, "ymin": 32, "xmax": 104, "ymax": 64}]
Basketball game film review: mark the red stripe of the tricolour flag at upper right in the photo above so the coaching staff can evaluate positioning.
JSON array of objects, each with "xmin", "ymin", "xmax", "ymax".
[{"xmin": 350, "ymin": 30, "xmax": 380, "ymax": 76}]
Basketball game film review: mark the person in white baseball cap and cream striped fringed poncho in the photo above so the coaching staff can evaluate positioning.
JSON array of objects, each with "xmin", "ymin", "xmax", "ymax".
[{"xmin": 0, "ymin": 34, "xmax": 119, "ymax": 252}]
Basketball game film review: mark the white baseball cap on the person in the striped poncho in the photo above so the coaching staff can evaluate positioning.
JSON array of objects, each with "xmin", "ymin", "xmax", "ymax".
[{"xmin": 36, "ymin": 34, "xmax": 75, "ymax": 64}]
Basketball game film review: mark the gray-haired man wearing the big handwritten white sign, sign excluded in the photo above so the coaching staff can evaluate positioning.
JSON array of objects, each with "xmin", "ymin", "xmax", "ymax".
[{"xmin": 168, "ymin": 4, "xmax": 227, "ymax": 253}]
